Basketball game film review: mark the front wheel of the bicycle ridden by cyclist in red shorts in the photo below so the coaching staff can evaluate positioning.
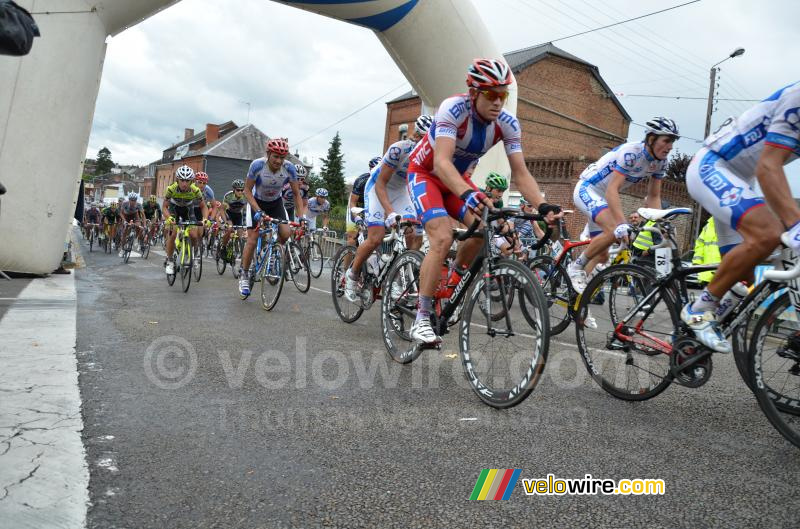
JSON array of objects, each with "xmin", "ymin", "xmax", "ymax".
[{"xmin": 459, "ymin": 258, "xmax": 550, "ymax": 408}]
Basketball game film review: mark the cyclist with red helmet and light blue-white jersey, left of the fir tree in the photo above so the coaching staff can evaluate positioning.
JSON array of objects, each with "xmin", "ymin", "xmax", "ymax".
[{"xmin": 239, "ymin": 138, "xmax": 305, "ymax": 296}]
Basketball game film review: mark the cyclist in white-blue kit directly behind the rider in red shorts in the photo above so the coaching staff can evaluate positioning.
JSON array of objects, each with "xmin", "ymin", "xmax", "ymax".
[{"xmin": 344, "ymin": 115, "xmax": 433, "ymax": 301}]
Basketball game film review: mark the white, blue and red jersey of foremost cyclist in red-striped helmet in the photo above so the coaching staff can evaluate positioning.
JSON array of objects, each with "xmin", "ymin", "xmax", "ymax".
[{"xmin": 409, "ymin": 94, "xmax": 522, "ymax": 174}]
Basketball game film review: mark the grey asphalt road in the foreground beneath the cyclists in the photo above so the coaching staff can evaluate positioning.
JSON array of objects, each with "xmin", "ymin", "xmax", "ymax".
[{"xmin": 77, "ymin": 241, "xmax": 800, "ymax": 528}]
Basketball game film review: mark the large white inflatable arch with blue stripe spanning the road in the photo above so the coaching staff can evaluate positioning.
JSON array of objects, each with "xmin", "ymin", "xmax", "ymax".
[{"xmin": 0, "ymin": 0, "xmax": 516, "ymax": 274}]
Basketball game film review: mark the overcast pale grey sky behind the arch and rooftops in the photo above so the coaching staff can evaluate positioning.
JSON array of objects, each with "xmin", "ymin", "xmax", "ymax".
[{"xmin": 87, "ymin": 0, "xmax": 800, "ymax": 195}]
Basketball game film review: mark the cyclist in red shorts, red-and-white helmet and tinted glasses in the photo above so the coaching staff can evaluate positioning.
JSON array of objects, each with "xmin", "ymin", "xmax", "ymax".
[{"xmin": 408, "ymin": 59, "xmax": 561, "ymax": 344}]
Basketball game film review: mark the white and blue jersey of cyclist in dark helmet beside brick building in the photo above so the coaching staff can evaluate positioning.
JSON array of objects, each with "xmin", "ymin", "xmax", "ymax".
[{"xmin": 579, "ymin": 141, "xmax": 667, "ymax": 194}]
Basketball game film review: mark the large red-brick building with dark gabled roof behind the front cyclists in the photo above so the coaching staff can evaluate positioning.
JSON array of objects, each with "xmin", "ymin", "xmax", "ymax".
[{"xmin": 384, "ymin": 43, "xmax": 691, "ymax": 249}]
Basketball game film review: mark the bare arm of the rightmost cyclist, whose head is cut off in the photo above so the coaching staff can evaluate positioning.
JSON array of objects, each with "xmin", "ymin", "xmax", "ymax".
[{"xmin": 756, "ymin": 145, "xmax": 800, "ymax": 228}]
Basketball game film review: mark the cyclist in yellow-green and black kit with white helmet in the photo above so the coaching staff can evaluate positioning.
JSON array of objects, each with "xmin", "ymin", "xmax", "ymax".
[{"xmin": 162, "ymin": 165, "xmax": 208, "ymax": 275}]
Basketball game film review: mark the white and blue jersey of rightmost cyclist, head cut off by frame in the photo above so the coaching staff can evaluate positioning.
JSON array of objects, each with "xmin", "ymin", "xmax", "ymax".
[{"xmin": 700, "ymin": 81, "xmax": 800, "ymax": 175}]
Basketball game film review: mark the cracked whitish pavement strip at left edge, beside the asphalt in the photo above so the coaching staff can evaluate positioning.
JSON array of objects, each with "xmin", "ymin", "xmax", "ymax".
[{"xmin": 0, "ymin": 274, "xmax": 89, "ymax": 529}]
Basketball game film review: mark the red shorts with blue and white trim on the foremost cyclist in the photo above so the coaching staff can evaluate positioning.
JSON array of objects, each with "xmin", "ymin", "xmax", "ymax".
[{"xmin": 408, "ymin": 167, "xmax": 478, "ymax": 226}]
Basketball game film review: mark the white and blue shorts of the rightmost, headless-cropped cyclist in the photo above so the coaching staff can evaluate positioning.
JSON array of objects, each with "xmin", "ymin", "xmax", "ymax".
[{"xmin": 686, "ymin": 147, "xmax": 766, "ymax": 254}]
